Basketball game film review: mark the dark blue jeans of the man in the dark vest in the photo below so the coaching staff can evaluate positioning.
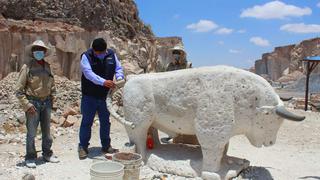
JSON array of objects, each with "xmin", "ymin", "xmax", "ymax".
[{"xmin": 79, "ymin": 95, "xmax": 111, "ymax": 148}]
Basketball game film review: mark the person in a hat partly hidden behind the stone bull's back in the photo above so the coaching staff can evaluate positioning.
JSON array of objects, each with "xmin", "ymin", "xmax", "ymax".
[{"xmin": 166, "ymin": 45, "xmax": 192, "ymax": 71}]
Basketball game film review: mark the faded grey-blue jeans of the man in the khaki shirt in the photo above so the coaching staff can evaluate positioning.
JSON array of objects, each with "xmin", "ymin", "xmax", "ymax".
[{"xmin": 25, "ymin": 99, "xmax": 52, "ymax": 160}]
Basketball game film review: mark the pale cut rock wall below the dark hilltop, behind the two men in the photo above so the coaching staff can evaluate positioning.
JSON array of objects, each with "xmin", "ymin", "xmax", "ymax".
[{"xmin": 0, "ymin": 17, "xmax": 182, "ymax": 80}]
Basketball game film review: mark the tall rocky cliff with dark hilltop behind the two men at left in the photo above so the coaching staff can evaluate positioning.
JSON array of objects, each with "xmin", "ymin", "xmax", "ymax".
[{"xmin": 0, "ymin": 0, "xmax": 182, "ymax": 80}]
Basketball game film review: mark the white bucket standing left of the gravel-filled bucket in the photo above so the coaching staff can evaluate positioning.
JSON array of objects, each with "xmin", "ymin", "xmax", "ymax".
[{"xmin": 90, "ymin": 161, "xmax": 124, "ymax": 180}]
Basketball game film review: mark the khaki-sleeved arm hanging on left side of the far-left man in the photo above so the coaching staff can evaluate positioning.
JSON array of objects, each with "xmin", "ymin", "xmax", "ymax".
[{"xmin": 15, "ymin": 65, "xmax": 33, "ymax": 112}]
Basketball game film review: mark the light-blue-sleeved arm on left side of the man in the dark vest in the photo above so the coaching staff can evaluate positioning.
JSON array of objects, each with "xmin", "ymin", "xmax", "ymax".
[{"xmin": 80, "ymin": 55, "xmax": 106, "ymax": 86}]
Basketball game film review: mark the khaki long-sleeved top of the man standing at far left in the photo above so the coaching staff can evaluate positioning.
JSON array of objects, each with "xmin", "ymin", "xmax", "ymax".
[{"xmin": 15, "ymin": 58, "xmax": 56, "ymax": 112}]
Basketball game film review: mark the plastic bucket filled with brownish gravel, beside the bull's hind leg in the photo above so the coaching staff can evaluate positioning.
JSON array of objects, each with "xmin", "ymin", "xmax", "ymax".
[{"xmin": 112, "ymin": 152, "xmax": 142, "ymax": 180}]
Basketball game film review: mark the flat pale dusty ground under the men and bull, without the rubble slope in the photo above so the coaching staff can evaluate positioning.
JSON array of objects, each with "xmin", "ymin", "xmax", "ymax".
[{"xmin": 0, "ymin": 108, "xmax": 320, "ymax": 180}]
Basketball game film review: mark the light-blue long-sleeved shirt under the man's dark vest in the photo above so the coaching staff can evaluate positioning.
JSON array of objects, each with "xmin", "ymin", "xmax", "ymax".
[{"xmin": 80, "ymin": 54, "xmax": 124, "ymax": 86}]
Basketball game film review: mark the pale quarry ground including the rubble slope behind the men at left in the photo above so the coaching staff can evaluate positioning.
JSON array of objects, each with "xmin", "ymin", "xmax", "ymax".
[{"xmin": 0, "ymin": 73, "xmax": 320, "ymax": 180}]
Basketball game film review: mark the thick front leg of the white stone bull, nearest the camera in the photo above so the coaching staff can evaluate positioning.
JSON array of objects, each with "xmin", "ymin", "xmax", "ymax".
[{"xmin": 195, "ymin": 92, "xmax": 234, "ymax": 179}]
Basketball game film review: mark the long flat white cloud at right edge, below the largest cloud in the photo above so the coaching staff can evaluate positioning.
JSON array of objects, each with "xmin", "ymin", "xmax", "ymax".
[{"xmin": 280, "ymin": 23, "xmax": 320, "ymax": 34}]
